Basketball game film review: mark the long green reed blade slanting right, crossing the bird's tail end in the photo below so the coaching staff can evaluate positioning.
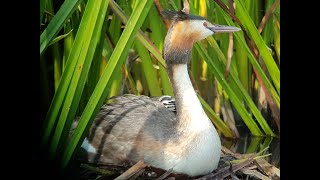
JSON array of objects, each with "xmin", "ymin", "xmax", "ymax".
[{"xmin": 61, "ymin": 0, "xmax": 152, "ymax": 168}]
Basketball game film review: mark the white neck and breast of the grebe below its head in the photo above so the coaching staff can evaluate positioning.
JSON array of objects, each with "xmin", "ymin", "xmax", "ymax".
[{"xmin": 167, "ymin": 64, "xmax": 221, "ymax": 176}]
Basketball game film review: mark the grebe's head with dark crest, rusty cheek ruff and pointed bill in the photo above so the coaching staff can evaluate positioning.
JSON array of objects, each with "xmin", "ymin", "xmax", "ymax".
[{"xmin": 162, "ymin": 10, "xmax": 241, "ymax": 64}]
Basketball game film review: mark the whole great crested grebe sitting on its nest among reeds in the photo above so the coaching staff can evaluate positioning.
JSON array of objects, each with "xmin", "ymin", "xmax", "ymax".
[{"xmin": 75, "ymin": 11, "xmax": 240, "ymax": 176}]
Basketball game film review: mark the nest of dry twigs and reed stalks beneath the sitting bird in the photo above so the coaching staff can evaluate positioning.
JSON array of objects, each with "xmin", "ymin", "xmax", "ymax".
[{"xmin": 80, "ymin": 147, "xmax": 280, "ymax": 180}]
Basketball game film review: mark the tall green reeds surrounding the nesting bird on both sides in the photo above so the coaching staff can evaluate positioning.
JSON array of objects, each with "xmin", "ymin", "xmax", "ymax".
[{"xmin": 40, "ymin": 0, "xmax": 280, "ymax": 172}]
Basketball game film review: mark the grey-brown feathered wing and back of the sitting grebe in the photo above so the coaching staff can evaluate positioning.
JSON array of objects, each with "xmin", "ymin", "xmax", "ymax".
[{"xmin": 82, "ymin": 94, "xmax": 176, "ymax": 164}]
